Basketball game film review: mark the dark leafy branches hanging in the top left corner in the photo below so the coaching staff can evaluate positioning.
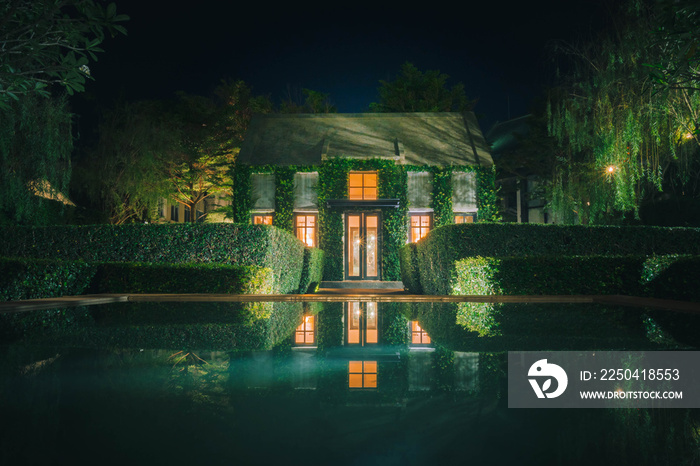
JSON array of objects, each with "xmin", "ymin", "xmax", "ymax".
[{"xmin": 0, "ymin": 0, "xmax": 129, "ymax": 105}]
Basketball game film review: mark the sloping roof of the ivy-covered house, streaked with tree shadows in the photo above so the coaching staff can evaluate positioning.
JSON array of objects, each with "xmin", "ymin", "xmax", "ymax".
[{"xmin": 238, "ymin": 112, "xmax": 493, "ymax": 166}]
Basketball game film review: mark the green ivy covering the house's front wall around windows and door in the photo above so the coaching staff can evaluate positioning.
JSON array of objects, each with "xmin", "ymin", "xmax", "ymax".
[{"xmin": 232, "ymin": 158, "xmax": 500, "ymax": 281}]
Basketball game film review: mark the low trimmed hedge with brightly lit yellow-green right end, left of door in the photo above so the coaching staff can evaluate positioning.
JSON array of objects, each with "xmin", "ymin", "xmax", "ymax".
[{"xmin": 92, "ymin": 262, "xmax": 274, "ymax": 294}]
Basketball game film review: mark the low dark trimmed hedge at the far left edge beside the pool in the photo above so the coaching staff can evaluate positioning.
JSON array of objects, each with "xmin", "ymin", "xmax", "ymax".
[{"xmin": 0, "ymin": 258, "xmax": 96, "ymax": 301}]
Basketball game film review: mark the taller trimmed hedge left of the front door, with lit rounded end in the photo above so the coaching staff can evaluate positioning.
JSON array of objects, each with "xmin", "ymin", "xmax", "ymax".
[{"xmin": 0, "ymin": 224, "xmax": 304, "ymax": 293}]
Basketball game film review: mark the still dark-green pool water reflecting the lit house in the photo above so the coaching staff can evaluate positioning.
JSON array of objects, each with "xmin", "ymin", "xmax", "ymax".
[{"xmin": 0, "ymin": 302, "xmax": 700, "ymax": 465}]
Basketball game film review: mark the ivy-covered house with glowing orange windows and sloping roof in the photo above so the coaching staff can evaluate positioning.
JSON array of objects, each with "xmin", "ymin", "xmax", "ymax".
[{"xmin": 233, "ymin": 112, "xmax": 495, "ymax": 281}]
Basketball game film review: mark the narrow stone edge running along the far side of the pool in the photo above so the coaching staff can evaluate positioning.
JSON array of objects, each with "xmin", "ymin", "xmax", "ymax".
[{"xmin": 0, "ymin": 289, "xmax": 700, "ymax": 314}]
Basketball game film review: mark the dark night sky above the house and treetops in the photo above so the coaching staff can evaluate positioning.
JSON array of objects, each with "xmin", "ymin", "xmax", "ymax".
[{"xmin": 78, "ymin": 0, "xmax": 611, "ymax": 132}]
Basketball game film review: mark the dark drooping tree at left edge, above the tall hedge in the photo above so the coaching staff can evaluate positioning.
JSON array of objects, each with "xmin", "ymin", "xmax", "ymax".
[{"xmin": 0, "ymin": 95, "xmax": 73, "ymax": 225}]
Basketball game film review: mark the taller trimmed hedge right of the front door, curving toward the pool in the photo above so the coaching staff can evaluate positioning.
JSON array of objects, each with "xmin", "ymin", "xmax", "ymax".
[{"xmin": 402, "ymin": 224, "xmax": 700, "ymax": 294}]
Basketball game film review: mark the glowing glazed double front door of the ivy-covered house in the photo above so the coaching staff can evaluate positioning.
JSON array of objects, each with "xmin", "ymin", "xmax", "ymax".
[{"xmin": 345, "ymin": 212, "xmax": 380, "ymax": 280}]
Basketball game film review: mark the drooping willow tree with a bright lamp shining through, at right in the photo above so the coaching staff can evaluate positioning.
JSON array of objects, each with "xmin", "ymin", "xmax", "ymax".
[{"xmin": 547, "ymin": 1, "xmax": 700, "ymax": 223}]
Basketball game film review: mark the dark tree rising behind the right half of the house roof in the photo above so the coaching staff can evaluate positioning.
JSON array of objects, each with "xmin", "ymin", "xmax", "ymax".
[{"xmin": 370, "ymin": 62, "xmax": 476, "ymax": 113}]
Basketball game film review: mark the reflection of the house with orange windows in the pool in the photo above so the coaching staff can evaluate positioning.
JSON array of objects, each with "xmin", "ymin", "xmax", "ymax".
[{"xmin": 291, "ymin": 302, "xmax": 479, "ymax": 393}]
